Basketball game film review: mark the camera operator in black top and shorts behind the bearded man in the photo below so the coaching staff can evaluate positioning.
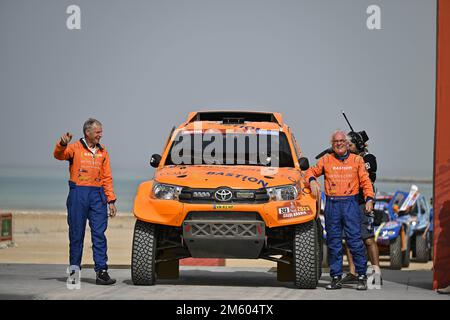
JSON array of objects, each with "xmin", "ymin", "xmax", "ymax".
[{"xmin": 342, "ymin": 131, "xmax": 382, "ymax": 285}]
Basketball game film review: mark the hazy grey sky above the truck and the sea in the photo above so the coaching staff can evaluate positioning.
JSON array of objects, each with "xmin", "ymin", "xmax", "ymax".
[{"xmin": 0, "ymin": 0, "xmax": 436, "ymax": 178}]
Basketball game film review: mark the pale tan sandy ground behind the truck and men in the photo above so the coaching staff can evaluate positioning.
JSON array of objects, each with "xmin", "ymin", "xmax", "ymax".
[{"xmin": 0, "ymin": 211, "xmax": 432, "ymax": 270}]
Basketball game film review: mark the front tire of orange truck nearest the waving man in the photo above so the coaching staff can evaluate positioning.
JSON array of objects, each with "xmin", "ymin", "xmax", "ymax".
[{"xmin": 131, "ymin": 220, "xmax": 156, "ymax": 286}]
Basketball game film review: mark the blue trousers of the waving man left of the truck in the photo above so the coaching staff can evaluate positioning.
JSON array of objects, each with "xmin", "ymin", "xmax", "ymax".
[{"xmin": 67, "ymin": 181, "xmax": 108, "ymax": 272}]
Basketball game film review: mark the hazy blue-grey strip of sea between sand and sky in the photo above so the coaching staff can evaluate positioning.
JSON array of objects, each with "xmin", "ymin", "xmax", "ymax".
[{"xmin": 0, "ymin": 165, "xmax": 433, "ymax": 213}]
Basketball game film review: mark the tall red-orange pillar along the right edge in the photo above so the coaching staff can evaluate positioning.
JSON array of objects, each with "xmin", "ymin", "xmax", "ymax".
[{"xmin": 433, "ymin": 0, "xmax": 450, "ymax": 289}]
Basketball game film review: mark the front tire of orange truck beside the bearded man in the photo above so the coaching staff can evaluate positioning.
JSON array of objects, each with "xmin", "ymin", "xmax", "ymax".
[{"xmin": 292, "ymin": 220, "xmax": 320, "ymax": 289}]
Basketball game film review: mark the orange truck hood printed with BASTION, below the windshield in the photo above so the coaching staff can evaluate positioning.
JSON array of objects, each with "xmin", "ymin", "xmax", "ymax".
[{"xmin": 155, "ymin": 165, "xmax": 301, "ymax": 189}]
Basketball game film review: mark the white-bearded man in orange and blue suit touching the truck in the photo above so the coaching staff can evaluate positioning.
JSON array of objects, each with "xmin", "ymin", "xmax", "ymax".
[{"xmin": 305, "ymin": 130, "xmax": 374, "ymax": 290}]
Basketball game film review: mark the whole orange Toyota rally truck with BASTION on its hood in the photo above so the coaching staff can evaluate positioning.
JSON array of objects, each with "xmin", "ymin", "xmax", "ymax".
[{"xmin": 131, "ymin": 111, "xmax": 322, "ymax": 289}]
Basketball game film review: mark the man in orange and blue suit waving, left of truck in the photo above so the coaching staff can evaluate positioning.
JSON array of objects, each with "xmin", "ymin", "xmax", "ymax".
[{"xmin": 54, "ymin": 119, "xmax": 117, "ymax": 285}]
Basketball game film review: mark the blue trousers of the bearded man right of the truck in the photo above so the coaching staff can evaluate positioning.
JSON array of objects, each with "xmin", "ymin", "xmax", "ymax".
[{"xmin": 325, "ymin": 196, "xmax": 367, "ymax": 277}]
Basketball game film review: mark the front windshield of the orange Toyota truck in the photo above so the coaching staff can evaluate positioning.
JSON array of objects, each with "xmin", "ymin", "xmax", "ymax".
[{"xmin": 165, "ymin": 130, "xmax": 294, "ymax": 167}]
